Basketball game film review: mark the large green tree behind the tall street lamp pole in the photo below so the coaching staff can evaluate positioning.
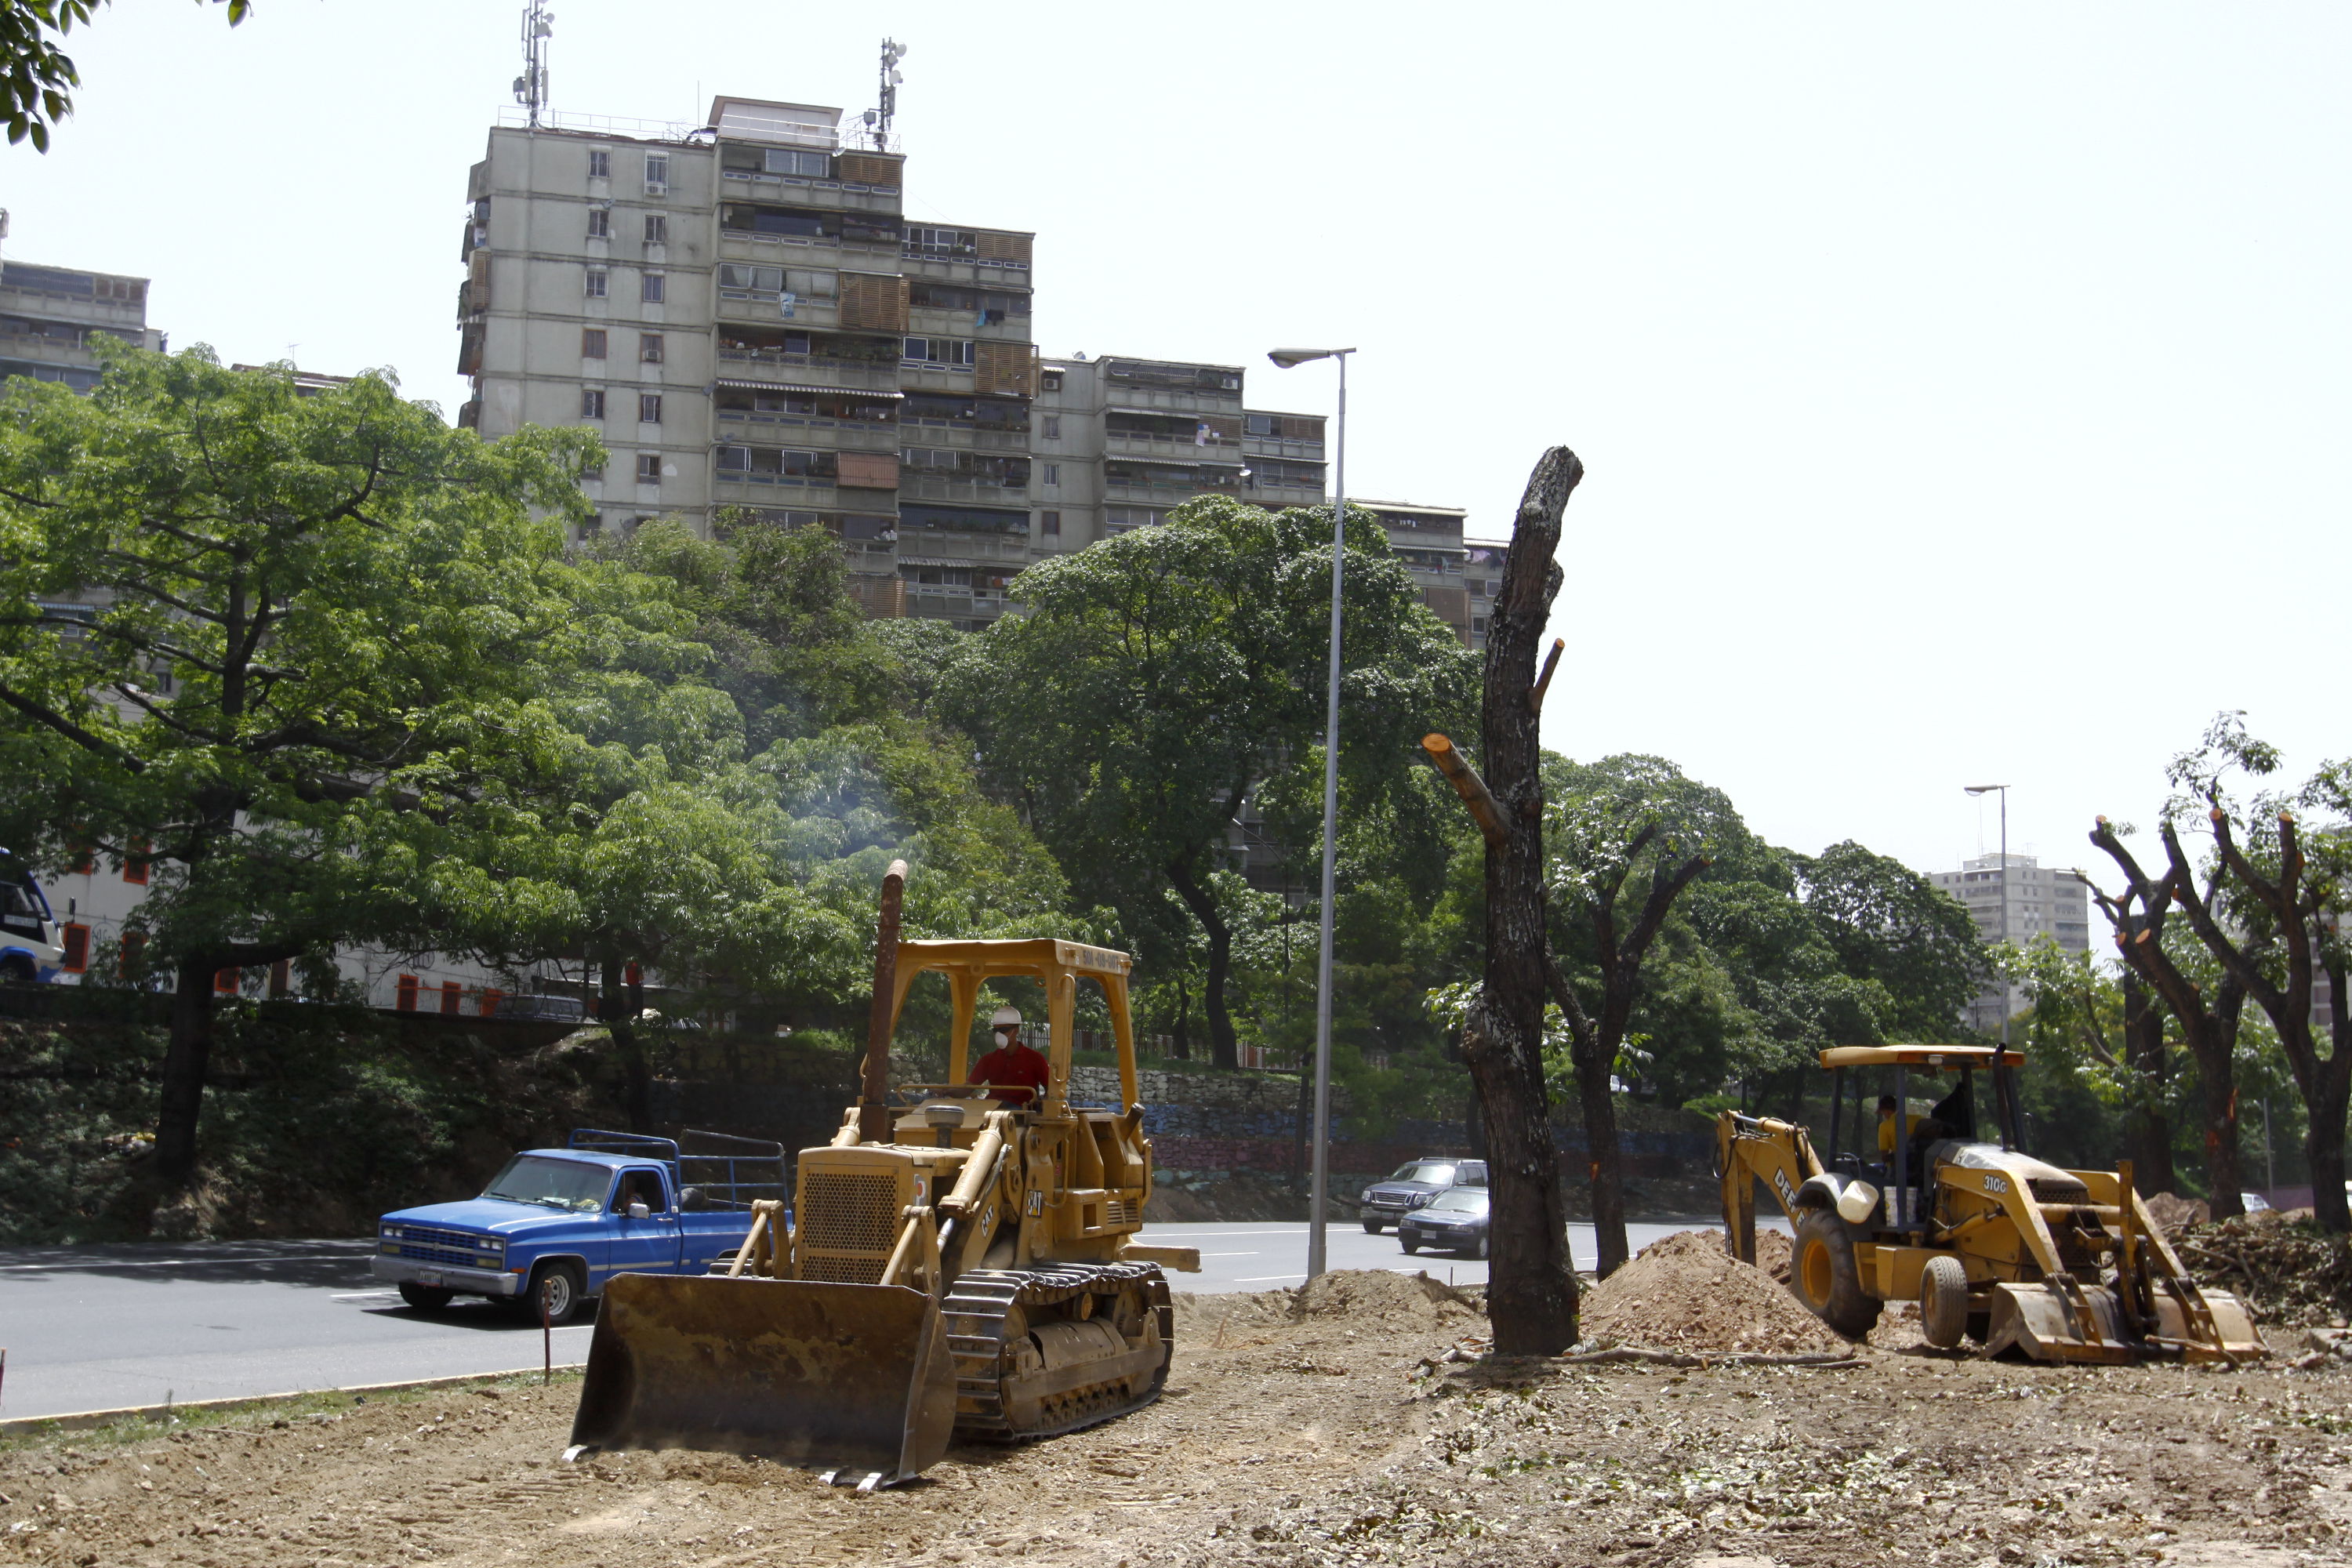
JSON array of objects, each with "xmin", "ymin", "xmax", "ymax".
[{"xmin": 941, "ymin": 496, "xmax": 1475, "ymax": 1067}]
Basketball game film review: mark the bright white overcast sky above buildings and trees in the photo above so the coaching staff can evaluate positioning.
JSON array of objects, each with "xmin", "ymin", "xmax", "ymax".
[{"xmin": 0, "ymin": 0, "xmax": 2352, "ymax": 888}]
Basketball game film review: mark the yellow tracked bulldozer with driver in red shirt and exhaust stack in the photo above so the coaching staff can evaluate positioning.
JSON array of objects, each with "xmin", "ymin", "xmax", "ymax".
[{"xmin": 567, "ymin": 862, "xmax": 1200, "ymax": 1490}]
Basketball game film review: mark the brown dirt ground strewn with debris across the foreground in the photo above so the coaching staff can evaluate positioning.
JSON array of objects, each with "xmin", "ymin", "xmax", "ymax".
[{"xmin": 0, "ymin": 1274, "xmax": 2352, "ymax": 1568}]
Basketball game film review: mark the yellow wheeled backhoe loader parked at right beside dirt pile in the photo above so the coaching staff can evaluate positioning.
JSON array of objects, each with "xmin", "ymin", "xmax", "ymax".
[{"xmin": 1715, "ymin": 1046, "xmax": 2267, "ymax": 1363}]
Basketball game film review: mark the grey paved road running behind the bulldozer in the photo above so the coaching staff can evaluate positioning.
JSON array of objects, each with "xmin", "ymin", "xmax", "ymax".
[{"xmin": 0, "ymin": 1222, "xmax": 1778, "ymax": 1420}]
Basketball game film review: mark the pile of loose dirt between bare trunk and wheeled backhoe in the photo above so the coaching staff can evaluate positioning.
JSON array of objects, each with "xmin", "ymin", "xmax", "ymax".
[{"xmin": 1583, "ymin": 1229, "xmax": 1853, "ymax": 1356}]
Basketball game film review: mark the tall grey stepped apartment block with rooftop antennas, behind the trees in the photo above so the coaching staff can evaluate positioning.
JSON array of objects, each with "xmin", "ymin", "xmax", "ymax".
[{"xmin": 459, "ymin": 96, "xmax": 1489, "ymax": 647}]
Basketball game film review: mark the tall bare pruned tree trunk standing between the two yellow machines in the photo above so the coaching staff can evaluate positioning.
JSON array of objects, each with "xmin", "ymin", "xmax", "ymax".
[{"xmin": 1463, "ymin": 447, "xmax": 1585, "ymax": 1356}]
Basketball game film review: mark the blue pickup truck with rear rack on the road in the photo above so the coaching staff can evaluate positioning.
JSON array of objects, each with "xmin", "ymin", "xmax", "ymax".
[{"xmin": 372, "ymin": 1128, "xmax": 788, "ymax": 1323}]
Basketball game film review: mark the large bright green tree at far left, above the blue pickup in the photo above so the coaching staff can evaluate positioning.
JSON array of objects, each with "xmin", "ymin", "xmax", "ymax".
[{"xmin": 0, "ymin": 348, "xmax": 600, "ymax": 1185}]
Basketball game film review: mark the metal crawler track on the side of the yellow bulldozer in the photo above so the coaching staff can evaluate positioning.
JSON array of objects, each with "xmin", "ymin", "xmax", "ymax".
[{"xmin": 943, "ymin": 1262, "xmax": 1176, "ymax": 1443}]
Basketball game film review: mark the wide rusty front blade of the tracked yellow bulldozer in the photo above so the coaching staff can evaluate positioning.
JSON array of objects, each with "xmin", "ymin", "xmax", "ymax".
[{"xmin": 572, "ymin": 1274, "xmax": 955, "ymax": 1490}]
